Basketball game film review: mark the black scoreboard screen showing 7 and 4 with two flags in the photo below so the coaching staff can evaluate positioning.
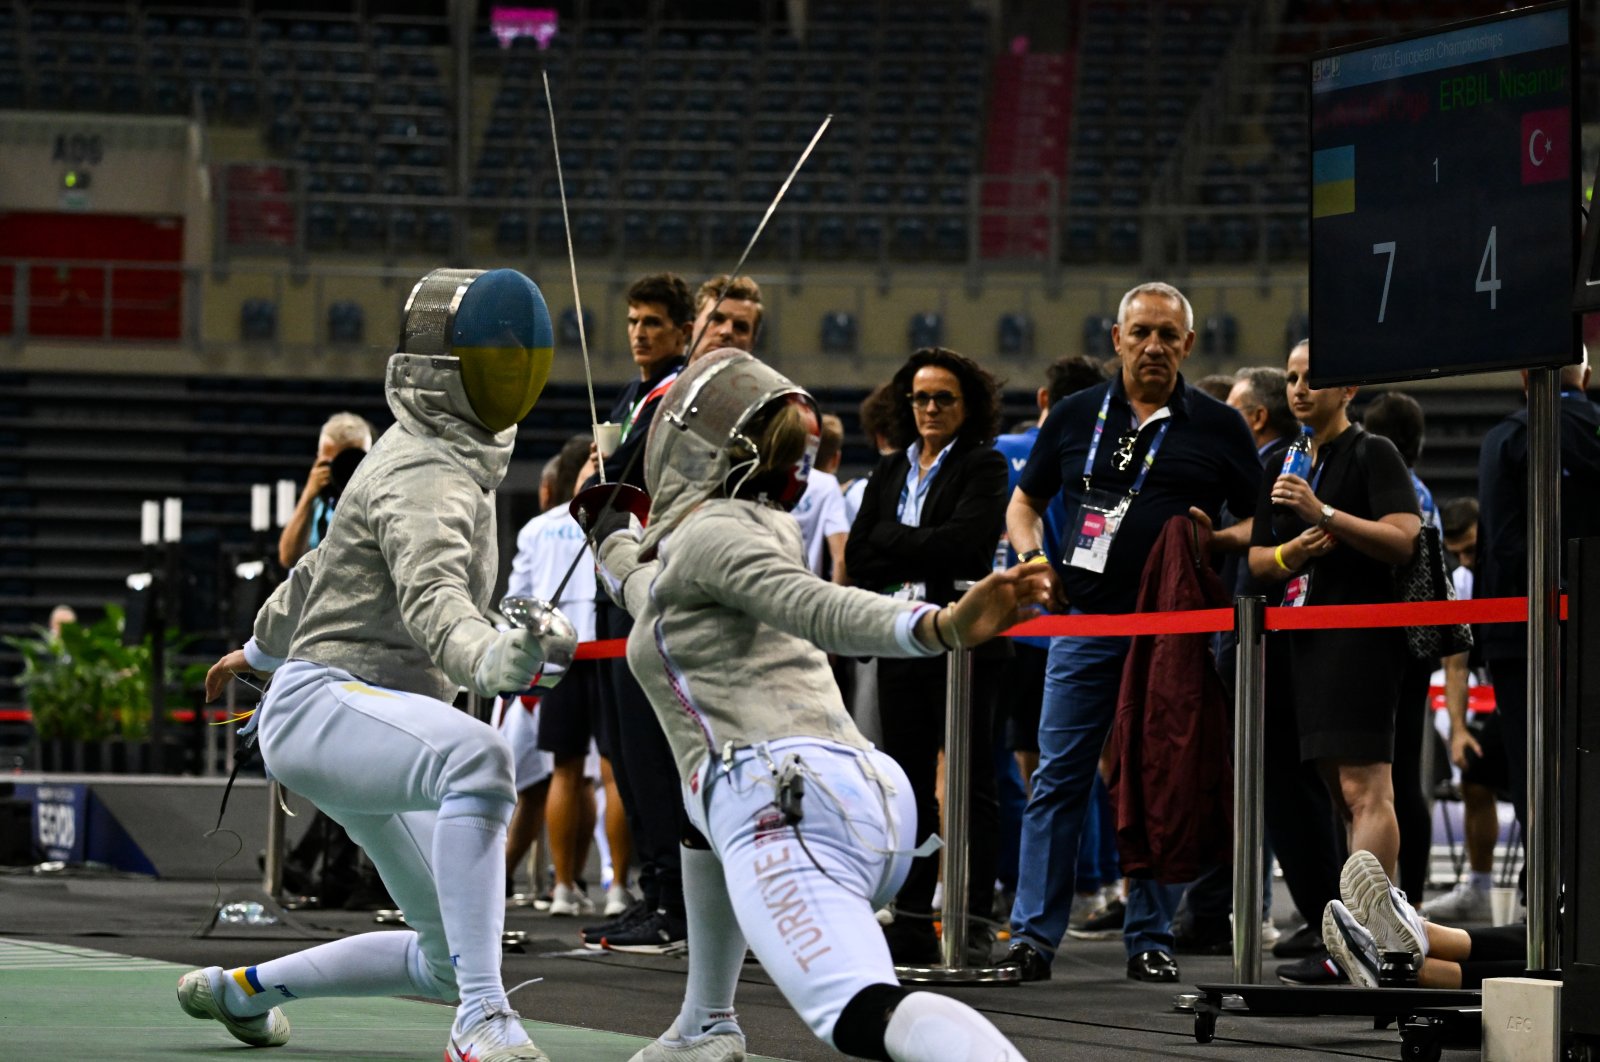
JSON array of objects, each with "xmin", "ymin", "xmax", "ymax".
[{"xmin": 1310, "ymin": 3, "xmax": 1579, "ymax": 387}]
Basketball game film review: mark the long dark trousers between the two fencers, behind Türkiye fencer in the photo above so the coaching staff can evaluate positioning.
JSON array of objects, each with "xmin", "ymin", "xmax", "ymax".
[{"xmin": 595, "ymin": 600, "xmax": 685, "ymax": 918}]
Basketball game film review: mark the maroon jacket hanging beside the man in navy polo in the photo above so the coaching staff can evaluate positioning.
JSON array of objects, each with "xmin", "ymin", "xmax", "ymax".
[{"xmin": 1107, "ymin": 517, "xmax": 1234, "ymax": 884}]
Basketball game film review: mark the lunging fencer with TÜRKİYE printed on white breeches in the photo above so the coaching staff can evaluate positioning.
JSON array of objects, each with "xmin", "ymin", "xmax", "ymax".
[{"xmin": 574, "ymin": 349, "xmax": 1046, "ymax": 1062}]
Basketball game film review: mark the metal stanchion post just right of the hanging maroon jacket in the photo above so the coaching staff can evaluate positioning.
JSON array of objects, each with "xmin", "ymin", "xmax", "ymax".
[{"xmin": 1234, "ymin": 597, "xmax": 1267, "ymax": 985}]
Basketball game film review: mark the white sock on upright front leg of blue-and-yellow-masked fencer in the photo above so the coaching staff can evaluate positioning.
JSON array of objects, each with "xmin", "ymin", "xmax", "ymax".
[{"xmin": 432, "ymin": 795, "xmax": 512, "ymax": 1025}]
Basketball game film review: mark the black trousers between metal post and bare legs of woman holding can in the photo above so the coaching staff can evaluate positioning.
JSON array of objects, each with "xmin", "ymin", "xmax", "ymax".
[{"xmin": 1261, "ymin": 637, "xmax": 1344, "ymax": 926}]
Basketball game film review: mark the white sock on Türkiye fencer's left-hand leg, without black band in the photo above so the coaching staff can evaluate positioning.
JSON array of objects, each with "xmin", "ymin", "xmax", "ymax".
[{"xmin": 677, "ymin": 848, "xmax": 744, "ymax": 1040}]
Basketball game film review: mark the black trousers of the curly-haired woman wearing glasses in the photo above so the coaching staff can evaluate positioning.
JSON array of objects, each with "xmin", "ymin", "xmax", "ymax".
[{"xmin": 878, "ymin": 656, "xmax": 1005, "ymax": 916}]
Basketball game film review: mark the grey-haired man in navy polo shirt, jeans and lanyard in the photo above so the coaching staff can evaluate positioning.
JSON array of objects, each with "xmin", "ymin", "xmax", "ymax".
[{"xmin": 1005, "ymin": 283, "xmax": 1261, "ymax": 982}]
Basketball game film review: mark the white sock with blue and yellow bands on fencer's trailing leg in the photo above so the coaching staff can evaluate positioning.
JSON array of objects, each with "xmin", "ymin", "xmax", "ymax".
[{"xmin": 222, "ymin": 931, "xmax": 438, "ymax": 1017}]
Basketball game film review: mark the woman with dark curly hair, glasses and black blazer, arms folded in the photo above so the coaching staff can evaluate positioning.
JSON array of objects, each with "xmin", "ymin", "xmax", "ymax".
[{"xmin": 845, "ymin": 347, "xmax": 1010, "ymax": 964}]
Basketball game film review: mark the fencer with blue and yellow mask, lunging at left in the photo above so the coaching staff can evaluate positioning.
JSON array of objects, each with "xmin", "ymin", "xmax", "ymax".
[{"xmin": 178, "ymin": 269, "xmax": 571, "ymax": 1062}]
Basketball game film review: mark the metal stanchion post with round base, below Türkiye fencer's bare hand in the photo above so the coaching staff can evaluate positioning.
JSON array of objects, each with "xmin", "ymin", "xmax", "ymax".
[{"xmin": 894, "ymin": 581, "xmax": 1022, "ymax": 985}]
